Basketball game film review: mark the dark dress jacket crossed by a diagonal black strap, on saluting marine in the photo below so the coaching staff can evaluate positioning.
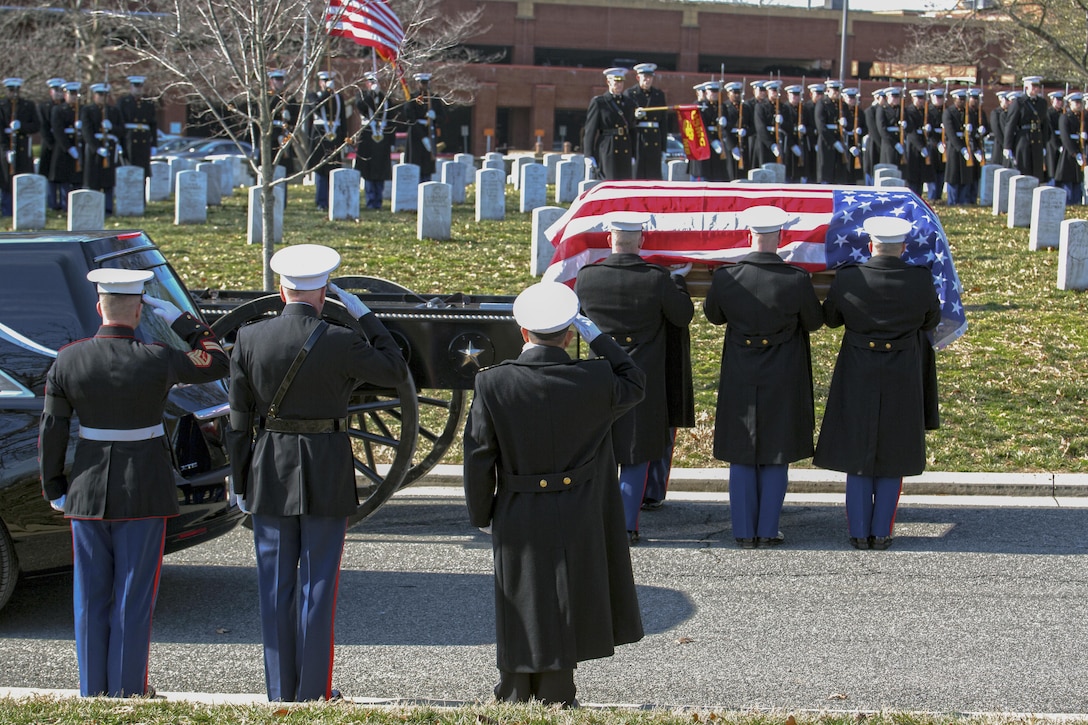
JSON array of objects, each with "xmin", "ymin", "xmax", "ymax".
[{"xmin": 228, "ymin": 303, "xmax": 408, "ymax": 516}]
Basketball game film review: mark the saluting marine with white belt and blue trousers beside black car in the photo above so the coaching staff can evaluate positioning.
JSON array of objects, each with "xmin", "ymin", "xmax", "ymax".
[{"xmin": 38, "ymin": 269, "xmax": 228, "ymax": 697}]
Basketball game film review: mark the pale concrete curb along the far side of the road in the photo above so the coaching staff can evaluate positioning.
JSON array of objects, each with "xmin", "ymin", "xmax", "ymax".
[{"xmin": 409, "ymin": 464, "xmax": 1088, "ymax": 499}]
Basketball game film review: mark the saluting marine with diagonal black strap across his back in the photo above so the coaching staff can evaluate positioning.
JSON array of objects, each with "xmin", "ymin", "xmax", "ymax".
[{"xmin": 227, "ymin": 244, "xmax": 408, "ymax": 701}]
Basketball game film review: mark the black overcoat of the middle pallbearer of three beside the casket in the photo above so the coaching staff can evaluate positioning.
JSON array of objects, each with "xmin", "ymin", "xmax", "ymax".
[{"xmin": 703, "ymin": 251, "xmax": 824, "ymax": 459}]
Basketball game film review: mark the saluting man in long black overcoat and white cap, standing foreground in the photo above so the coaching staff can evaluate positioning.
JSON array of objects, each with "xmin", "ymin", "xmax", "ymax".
[{"xmin": 465, "ymin": 282, "xmax": 645, "ymax": 705}]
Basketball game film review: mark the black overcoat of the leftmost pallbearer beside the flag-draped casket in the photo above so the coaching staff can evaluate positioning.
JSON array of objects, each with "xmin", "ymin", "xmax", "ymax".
[{"xmin": 574, "ymin": 254, "xmax": 695, "ymax": 464}]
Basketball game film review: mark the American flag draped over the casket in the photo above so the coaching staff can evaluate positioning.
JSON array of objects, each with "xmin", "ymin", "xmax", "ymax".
[{"xmin": 544, "ymin": 182, "xmax": 967, "ymax": 347}]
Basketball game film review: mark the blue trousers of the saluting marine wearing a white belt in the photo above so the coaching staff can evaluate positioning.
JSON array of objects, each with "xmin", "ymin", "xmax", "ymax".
[{"xmin": 72, "ymin": 517, "xmax": 166, "ymax": 698}]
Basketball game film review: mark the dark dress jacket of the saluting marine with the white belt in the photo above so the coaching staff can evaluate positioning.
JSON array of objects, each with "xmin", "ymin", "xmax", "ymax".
[{"xmin": 38, "ymin": 312, "xmax": 230, "ymax": 519}]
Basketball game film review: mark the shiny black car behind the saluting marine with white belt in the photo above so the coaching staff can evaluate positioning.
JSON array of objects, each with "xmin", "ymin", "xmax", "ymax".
[{"xmin": 0, "ymin": 231, "xmax": 243, "ymax": 607}]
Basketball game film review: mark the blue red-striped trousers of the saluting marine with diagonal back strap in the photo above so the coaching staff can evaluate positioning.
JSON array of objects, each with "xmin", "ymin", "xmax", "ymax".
[{"xmin": 252, "ymin": 515, "xmax": 347, "ymax": 702}]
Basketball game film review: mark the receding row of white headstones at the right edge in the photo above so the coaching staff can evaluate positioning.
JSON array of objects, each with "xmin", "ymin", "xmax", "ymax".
[{"xmin": 979, "ymin": 163, "xmax": 1088, "ymax": 290}]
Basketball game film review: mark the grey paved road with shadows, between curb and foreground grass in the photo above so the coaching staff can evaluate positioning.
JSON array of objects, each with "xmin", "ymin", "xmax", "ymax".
[{"xmin": 0, "ymin": 489, "xmax": 1088, "ymax": 713}]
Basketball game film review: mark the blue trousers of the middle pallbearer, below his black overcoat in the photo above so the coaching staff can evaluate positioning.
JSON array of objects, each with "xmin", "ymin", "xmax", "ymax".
[{"xmin": 729, "ymin": 463, "xmax": 790, "ymax": 539}]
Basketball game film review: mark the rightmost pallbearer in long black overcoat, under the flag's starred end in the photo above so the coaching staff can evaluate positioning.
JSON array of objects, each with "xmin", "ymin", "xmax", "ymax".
[{"xmin": 813, "ymin": 217, "xmax": 940, "ymax": 549}]
